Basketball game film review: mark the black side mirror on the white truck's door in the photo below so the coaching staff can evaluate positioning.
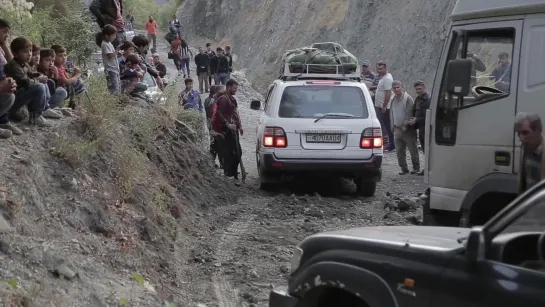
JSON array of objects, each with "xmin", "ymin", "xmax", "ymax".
[{"xmin": 446, "ymin": 59, "xmax": 473, "ymax": 97}]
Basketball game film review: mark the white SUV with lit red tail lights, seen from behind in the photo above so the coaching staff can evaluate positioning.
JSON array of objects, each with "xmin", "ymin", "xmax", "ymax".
[{"xmin": 251, "ymin": 65, "xmax": 383, "ymax": 196}]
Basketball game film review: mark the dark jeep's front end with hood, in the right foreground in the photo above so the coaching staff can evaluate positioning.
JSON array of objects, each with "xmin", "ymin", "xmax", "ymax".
[{"xmin": 269, "ymin": 181, "xmax": 545, "ymax": 307}]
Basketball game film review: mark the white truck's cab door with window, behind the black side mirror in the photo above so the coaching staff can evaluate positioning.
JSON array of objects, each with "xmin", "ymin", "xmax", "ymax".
[{"xmin": 428, "ymin": 20, "xmax": 523, "ymax": 211}]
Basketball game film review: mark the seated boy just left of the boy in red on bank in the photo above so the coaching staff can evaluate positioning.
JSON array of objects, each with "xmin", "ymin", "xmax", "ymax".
[{"xmin": 37, "ymin": 49, "xmax": 68, "ymax": 118}]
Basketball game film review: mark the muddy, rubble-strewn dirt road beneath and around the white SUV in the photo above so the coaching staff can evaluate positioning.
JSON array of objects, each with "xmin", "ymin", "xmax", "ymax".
[{"xmin": 167, "ymin": 64, "xmax": 425, "ymax": 307}]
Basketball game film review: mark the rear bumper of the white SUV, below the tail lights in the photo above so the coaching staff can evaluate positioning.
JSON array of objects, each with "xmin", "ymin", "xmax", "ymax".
[{"xmin": 261, "ymin": 153, "xmax": 382, "ymax": 178}]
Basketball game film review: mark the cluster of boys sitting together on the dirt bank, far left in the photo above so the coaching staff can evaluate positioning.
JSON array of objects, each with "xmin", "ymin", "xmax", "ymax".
[{"xmin": 0, "ymin": 19, "xmax": 85, "ymax": 138}]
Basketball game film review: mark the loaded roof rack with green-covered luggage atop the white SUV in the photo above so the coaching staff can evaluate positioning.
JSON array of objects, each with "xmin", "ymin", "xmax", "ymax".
[{"xmin": 280, "ymin": 43, "xmax": 361, "ymax": 80}]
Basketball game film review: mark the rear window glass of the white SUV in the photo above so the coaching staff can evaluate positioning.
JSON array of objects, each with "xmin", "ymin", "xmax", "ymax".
[{"xmin": 278, "ymin": 85, "xmax": 369, "ymax": 118}]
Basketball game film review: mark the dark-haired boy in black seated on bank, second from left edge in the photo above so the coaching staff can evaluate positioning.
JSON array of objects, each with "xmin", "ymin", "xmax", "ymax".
[{"xmin": 4, "ymin": 37, "xmax": 50, "ymax": 127}]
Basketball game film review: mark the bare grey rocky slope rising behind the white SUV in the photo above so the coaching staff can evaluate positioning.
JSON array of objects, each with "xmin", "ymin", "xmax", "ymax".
[{"xmin": 180, "ymin": 0, "xmax": 456, "ymax": 94}]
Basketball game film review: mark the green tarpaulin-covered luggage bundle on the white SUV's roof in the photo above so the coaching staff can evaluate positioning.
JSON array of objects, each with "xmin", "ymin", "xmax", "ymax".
[{"xmin": 281, "ymin": 42, "xmax": 358, "ymax": 74}]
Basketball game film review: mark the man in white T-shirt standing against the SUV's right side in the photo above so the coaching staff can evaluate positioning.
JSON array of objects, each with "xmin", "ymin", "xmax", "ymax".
[{"xmin": 371, "ymin": 61, "xmax": 395, "ymax": 151}]
